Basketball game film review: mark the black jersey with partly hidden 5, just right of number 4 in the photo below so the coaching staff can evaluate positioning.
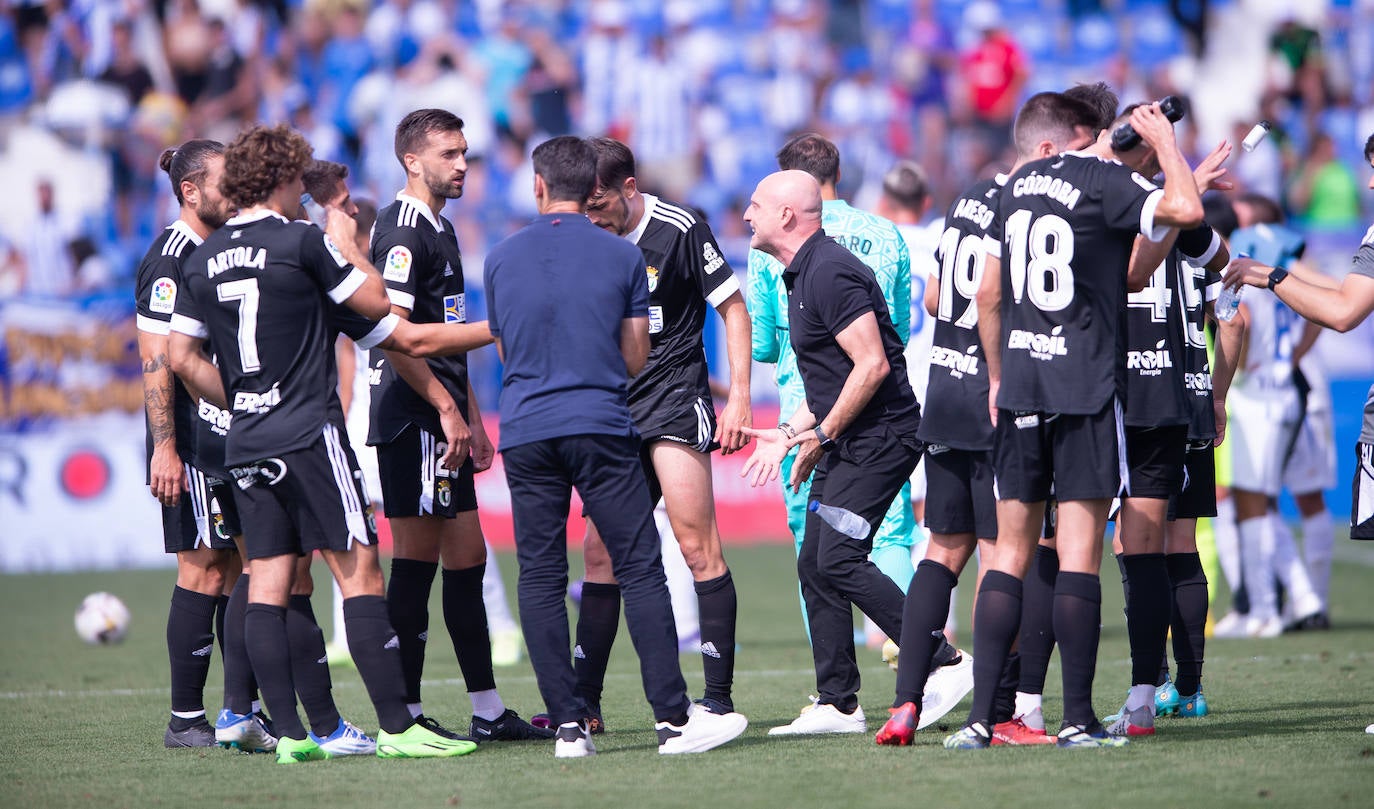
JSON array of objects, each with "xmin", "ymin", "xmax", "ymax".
[{"xmin": 1175, "ymin": 224, "xmax": 1221, "ymax": 441}]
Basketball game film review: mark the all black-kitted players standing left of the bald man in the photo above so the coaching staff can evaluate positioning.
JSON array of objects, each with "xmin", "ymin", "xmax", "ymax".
[{"xmin": 137, "ymin": 110, "xmax": 749, "ymax": 764}]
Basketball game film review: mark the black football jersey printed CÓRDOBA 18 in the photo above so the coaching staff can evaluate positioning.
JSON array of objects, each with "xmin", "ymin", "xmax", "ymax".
[{"xmin": 993, "ymin": 152, "xmax": 1168, "ymax": 415}]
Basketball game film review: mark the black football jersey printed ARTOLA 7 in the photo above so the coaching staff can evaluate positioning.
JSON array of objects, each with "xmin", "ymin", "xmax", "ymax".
[{"xmin": 172, "ymin": 212, "xmax": 367, "ymax": 467}]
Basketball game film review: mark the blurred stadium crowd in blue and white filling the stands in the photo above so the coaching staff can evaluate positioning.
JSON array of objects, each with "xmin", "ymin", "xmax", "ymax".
[{"xmin": 0, "ymin": 0, "xmax": 1374, "ymax": 295}]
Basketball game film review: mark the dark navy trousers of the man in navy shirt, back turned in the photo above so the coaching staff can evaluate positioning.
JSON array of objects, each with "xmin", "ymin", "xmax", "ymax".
[{"xmin": 502, "ymin": 435, "xmax": 688, "ymax": 724}]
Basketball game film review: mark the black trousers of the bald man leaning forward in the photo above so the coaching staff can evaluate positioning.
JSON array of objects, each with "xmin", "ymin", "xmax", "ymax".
[{"xmin": 797, "ymin": 426, "xmax": 922, "ymax": 713}]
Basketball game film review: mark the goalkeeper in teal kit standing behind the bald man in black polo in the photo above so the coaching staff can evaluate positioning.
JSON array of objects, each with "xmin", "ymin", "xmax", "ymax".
[{"xmin": 747, "ymin": 135, "xmax": 918, "ymax": 637}]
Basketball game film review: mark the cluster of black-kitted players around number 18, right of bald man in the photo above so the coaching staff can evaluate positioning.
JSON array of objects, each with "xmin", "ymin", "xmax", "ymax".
[{"xmin": 877, "ymin": 85, "xmax": 1239, "ymax": 749}]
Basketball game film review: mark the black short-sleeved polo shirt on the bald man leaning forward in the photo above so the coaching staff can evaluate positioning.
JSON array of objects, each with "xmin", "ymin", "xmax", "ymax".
[{"xmin": 782, "ymin": 229, "xmax": 921, "ymax": 434}]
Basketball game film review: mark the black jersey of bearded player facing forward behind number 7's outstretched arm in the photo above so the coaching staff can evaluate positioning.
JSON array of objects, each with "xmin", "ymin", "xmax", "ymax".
[{"xmin": 367, "ymin": 194, "xmax": 467, "ymax": 445}]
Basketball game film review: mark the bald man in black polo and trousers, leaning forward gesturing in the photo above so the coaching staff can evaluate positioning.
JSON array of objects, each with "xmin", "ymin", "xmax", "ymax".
[{"xmin": 745, "ymin": 170, "xmax": 922, "ymax": 735}]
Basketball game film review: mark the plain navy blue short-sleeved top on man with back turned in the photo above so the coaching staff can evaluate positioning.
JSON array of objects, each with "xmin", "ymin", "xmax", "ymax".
[{"xmin": 482, "ymin": 213, "xmax": 649, "ymax": 451}]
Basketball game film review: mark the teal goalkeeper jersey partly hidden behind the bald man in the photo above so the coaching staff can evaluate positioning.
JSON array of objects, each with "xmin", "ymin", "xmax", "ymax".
[{"xmin": 747, "ymin": 199, "xmax": 911, "ymax": 420}]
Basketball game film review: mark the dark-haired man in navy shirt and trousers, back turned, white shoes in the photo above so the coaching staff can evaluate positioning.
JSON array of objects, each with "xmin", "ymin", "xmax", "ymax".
[{"xmin": 484, "ymin": 136, "xmax": 747, "ymax": 758}]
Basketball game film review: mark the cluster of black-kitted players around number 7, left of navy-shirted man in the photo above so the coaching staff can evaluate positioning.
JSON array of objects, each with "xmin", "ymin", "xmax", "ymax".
[{"xmin": 137, "ymin": 110, "xmax": 552, "ymax": 762}]
